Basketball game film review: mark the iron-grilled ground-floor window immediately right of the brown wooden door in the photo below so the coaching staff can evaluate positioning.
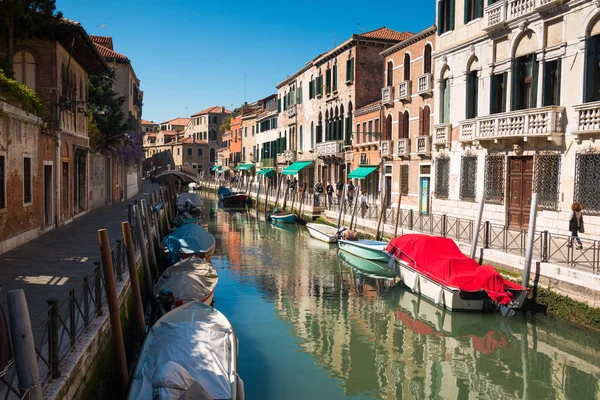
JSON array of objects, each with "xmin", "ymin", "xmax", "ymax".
[{"xmin": 534, "ymin": 151, "xmax": 561, "ymax": 210}]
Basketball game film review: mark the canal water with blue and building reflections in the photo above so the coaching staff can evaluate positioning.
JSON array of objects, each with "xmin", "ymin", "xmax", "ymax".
[{"xmin": 204, "ymin": 203, "xmax": 600, "ymax": 400}]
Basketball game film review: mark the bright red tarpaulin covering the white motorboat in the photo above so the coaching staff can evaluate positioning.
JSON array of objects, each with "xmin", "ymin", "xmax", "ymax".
[{"xmin": 387, "ymin": 234, "xmax": 524, "ymax": 304}]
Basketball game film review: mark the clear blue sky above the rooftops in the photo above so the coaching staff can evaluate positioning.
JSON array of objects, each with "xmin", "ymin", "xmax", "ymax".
[{"xmin": 56, "ymin": 0, "xmax": 435, "ymax": 122}]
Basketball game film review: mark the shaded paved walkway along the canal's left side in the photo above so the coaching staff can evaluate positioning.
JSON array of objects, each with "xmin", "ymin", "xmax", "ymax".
[{"xmin": 0, "ymin": 181, "xmax": 158, "ymax": 320}]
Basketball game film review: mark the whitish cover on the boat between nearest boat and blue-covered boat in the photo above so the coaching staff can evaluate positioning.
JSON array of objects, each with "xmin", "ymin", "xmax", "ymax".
[{"xmin": 154, "ymin": 257, "xmax": 219, "ymax": 303}]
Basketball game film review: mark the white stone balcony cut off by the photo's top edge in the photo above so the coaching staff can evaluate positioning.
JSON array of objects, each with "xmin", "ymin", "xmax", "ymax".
[{"xmin": 483, "ymin": 0, "xmax": 564, "ymax": 32}]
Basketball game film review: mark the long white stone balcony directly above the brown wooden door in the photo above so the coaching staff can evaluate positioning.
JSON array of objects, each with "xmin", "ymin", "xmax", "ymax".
[{"xmin": 460, "ymin": 106, "xmax": 565, "ymax": 145}]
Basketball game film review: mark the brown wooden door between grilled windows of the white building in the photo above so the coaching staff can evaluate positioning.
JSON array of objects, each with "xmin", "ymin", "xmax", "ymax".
[{"xmin": 507, "ymin": 157, "xmax": 533, "ymax": 228}]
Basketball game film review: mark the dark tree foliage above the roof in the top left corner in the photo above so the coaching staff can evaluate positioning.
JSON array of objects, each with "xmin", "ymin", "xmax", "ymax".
[{"xmin": 0, "ymin": 0, "xmax": 62, "ymax": 78}]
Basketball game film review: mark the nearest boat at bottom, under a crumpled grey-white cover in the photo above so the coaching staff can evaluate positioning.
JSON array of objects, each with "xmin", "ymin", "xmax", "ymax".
[{"xmin": 127, "ymin": 301, "xmax": 244, "ymax": 400}]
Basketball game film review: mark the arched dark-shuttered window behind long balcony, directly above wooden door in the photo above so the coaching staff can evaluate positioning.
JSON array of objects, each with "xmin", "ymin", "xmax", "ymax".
[{"xmin": 511, "ymin": 54, "xmax": 538, "ymax": 111}]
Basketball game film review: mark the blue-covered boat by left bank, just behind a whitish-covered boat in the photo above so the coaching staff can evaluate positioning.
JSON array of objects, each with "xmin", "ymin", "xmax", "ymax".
[{"xmin": 163, "ymin": 224, "xmax": 216, "ymax": 264}]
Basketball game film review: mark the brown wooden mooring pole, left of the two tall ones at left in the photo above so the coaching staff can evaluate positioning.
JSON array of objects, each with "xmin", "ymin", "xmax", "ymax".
[{"xmin": 98, "ymin": 229, "xmax": 129, "ymax": 393}]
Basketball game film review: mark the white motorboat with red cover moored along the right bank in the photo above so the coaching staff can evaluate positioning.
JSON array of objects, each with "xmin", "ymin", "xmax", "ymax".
[{"xmin": 386, "ymin": 234, "xmax": 527, "ymax": 316}]
